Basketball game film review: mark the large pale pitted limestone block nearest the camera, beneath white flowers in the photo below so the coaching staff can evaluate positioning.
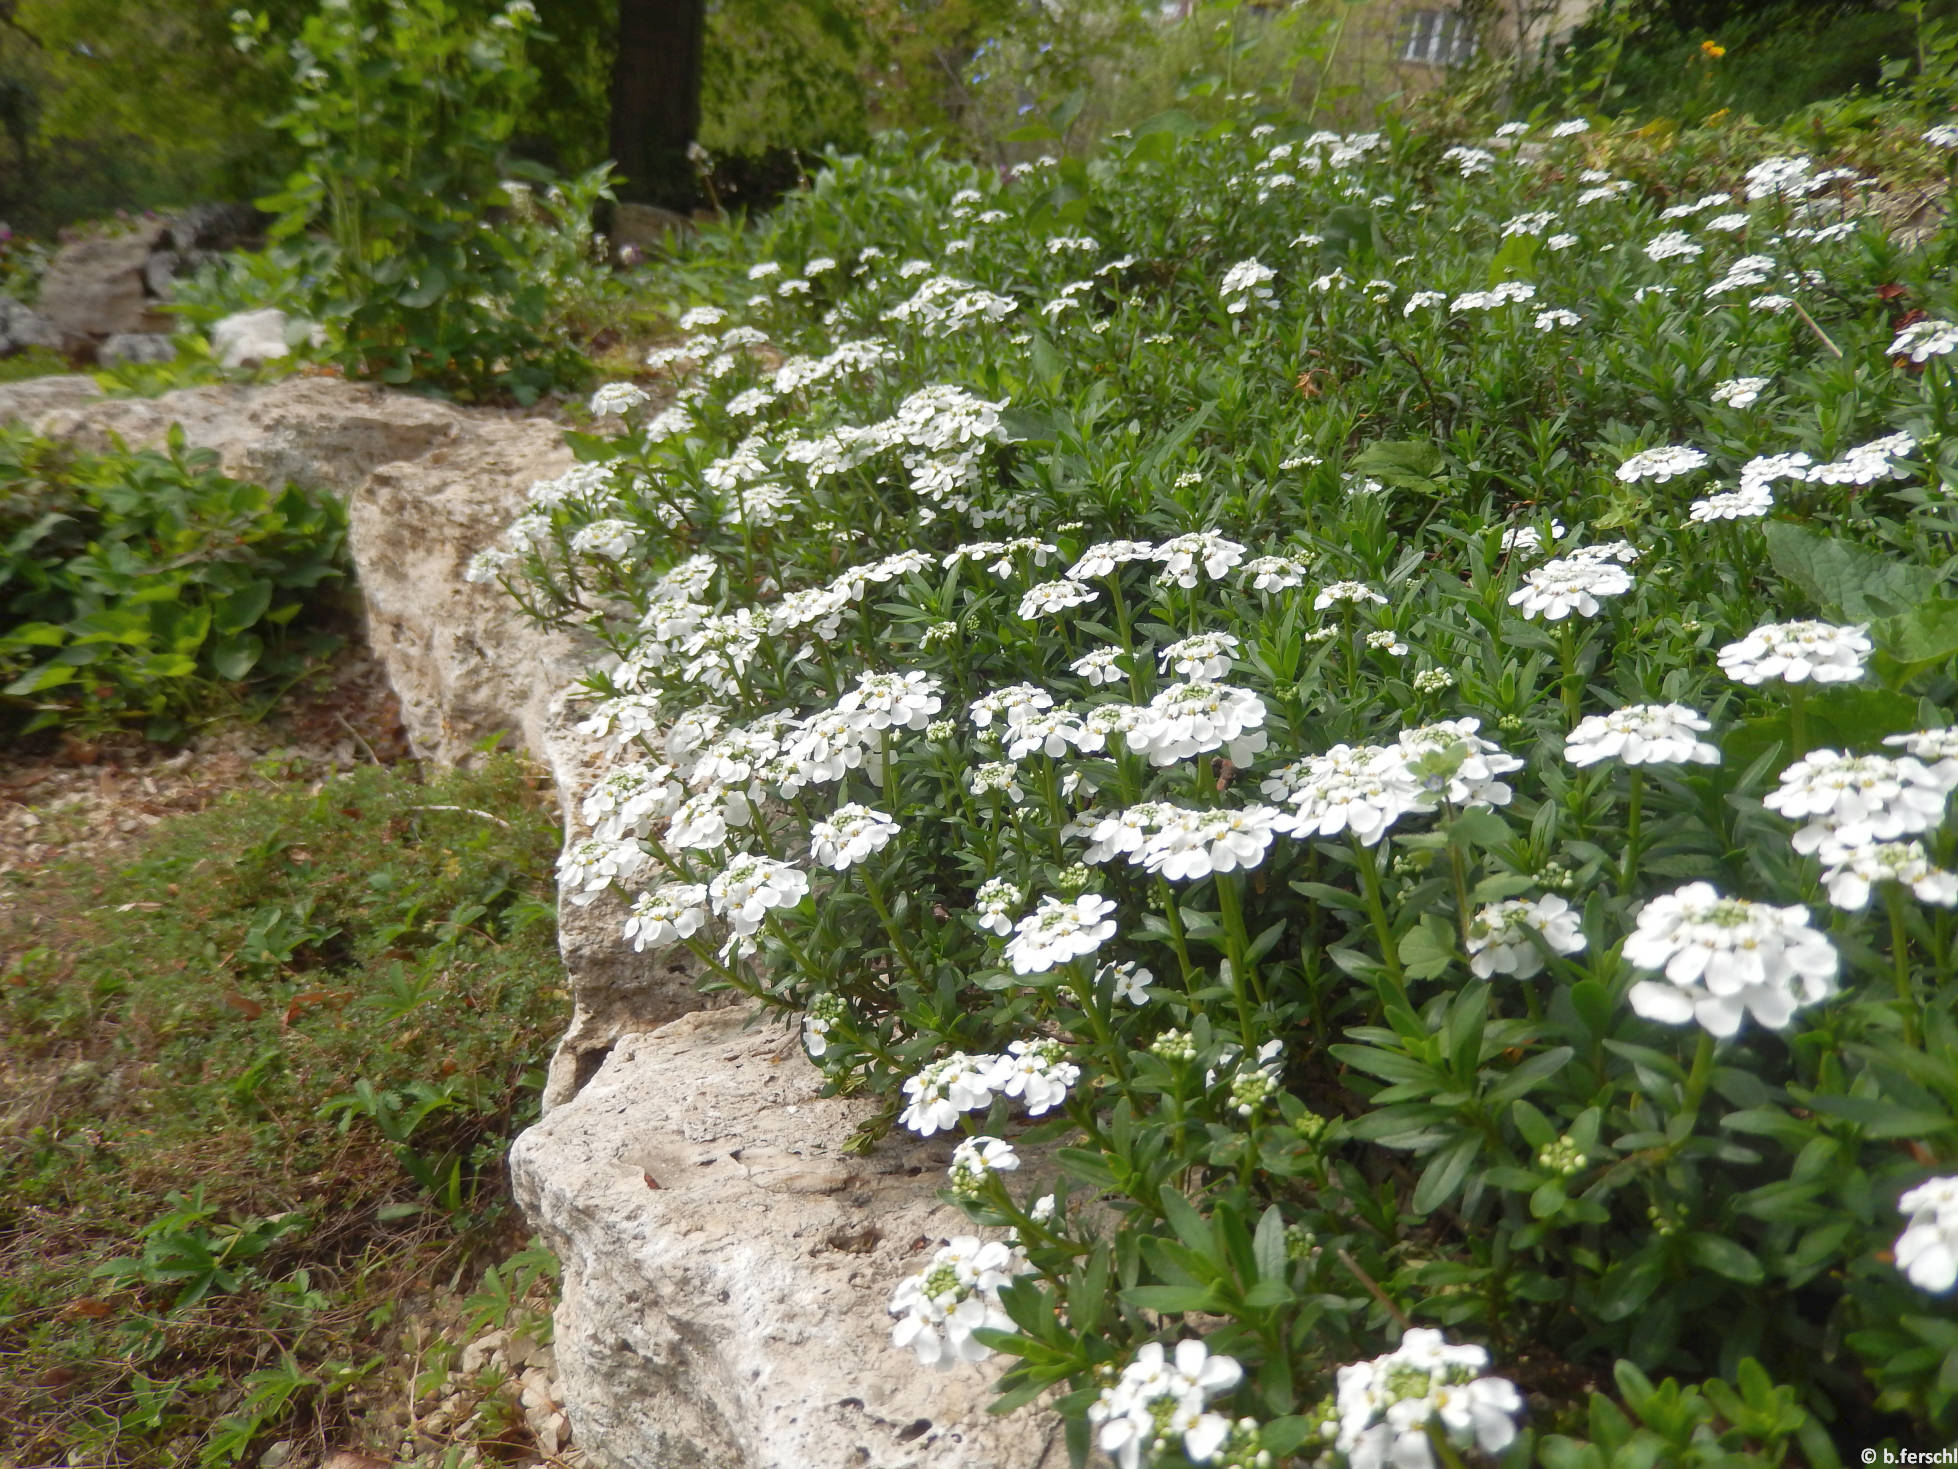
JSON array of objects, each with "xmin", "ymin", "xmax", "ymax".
[{"xmin": 511, "ymin": 1009, "xmax": 1067, "ymax": 1469}]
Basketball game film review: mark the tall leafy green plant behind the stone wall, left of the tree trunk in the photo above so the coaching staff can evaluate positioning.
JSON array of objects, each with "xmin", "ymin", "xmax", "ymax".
[{"xmin": 256, "ymin": 0, "xmax": 609, "ymax": 402}]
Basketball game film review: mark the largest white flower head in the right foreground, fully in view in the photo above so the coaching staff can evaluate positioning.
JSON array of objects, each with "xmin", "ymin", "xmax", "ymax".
[{"xmin": 1625, "ymin": 883, "xmax": 1839, "ymax": 1038}]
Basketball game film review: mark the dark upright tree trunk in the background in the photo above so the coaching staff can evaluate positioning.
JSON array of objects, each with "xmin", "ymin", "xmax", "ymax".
[{"xmin": 611, "ymin": 0, "xmax": 707, "ymax": 212}]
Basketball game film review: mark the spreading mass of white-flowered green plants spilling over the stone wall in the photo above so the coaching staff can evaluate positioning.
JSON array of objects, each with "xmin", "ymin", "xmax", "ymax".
[{"xmin": 472, "ymin": 116, "xmax": 1958, "ymax": 1469}]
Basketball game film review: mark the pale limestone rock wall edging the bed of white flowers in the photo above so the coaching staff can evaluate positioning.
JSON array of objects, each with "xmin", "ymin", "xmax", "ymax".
[{"xmin": 0, "ymin": 378, "xmax": 1065, "ymax": 1469}]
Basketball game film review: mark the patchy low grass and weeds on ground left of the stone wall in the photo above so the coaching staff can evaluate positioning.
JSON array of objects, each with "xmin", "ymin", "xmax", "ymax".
[{"xmin": 0, "ymin": 758, "xmax": 564, "ymax": 1469}]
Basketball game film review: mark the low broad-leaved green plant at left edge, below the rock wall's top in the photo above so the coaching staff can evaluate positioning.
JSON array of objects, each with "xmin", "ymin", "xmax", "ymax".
[{"xmin": 0, "ymin": 427, "xmax": 345, "ymax": 738}]
